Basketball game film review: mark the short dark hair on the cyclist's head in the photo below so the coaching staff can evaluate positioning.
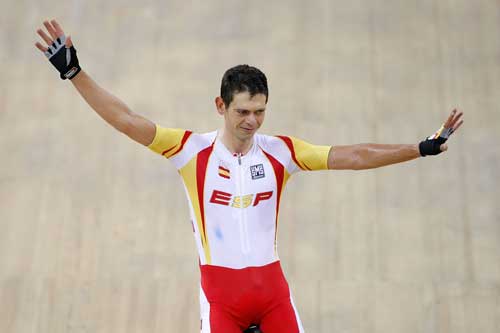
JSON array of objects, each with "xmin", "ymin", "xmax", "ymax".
[{"xmin": 220, "ymin": 65, "xmax": 269, "ymax": 107}]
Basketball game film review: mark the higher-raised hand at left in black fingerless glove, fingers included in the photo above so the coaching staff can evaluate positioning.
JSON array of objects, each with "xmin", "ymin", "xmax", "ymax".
[{"xmin": 35, "ymin": 20, "xmax": 81, "ymax": 80}]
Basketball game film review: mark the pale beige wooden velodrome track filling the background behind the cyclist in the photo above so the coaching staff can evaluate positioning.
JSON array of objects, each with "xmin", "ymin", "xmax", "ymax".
[{"xmin": 0, "ymin": 0, "xmax": 500, "ymax": 333}]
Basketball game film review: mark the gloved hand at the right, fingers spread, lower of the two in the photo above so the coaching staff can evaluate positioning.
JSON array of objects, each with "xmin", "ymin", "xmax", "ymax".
[{"xmin": 419, "ymin": 109, "xmax": 464, "ymax": 156}]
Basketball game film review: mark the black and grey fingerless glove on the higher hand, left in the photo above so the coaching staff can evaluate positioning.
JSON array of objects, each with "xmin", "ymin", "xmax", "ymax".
[{"xmin": 45, "ymin": 36, "xmax": 82, "ymax": 80}]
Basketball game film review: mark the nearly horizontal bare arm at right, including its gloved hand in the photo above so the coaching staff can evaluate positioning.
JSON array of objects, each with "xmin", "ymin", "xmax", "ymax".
[{"xmin": 328, "ymin": 110, "xmax": 463, "ymax": 170}]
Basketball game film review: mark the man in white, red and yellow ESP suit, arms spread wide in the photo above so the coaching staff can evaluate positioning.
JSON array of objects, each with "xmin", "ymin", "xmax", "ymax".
[{"xmin": 36, "ymin": 20, "xmax": 463, "ymax": 333}]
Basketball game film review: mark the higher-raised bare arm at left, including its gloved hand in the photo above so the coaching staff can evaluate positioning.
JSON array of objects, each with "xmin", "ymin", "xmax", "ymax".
[{"xmin": 35, "ymin": 20, "xmax": 156, "ymax": 146}]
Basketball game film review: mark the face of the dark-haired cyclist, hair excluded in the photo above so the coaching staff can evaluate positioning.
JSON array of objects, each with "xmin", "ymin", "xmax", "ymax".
[{"xmin": 215, "ymin": 92, "xmax": 266, "ymax": 141}]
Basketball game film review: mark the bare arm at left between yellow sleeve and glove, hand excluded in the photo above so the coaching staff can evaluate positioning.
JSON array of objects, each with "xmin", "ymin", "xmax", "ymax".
[{"xmin": 71, "ymin": 70, "xmax": 156, "ymax": 146}]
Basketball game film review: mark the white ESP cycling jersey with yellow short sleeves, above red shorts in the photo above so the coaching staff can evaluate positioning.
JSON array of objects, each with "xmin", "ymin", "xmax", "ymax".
[{"xmin": 149, "ymin": 125, "xmax": 330, "ymax": 269}]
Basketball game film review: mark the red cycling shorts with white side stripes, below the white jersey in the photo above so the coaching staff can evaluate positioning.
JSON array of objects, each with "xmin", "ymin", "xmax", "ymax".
[{"xmin": 200, "ymin": 261, "xmax": 304, "ymax": 333}]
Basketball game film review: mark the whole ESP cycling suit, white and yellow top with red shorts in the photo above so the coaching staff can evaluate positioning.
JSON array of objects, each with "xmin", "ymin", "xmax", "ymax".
[{"xmin": 149, "ymin": 125, "xmax": 330, "ymax": 333}]
